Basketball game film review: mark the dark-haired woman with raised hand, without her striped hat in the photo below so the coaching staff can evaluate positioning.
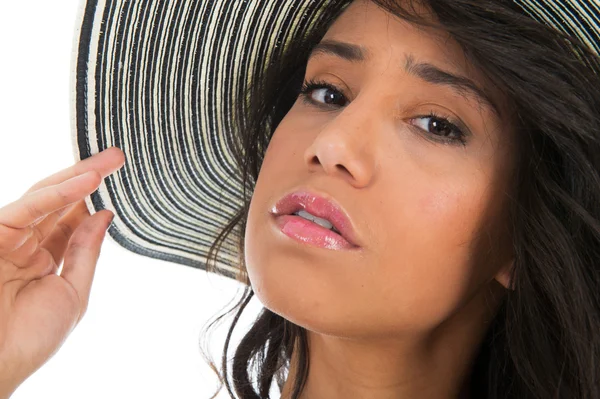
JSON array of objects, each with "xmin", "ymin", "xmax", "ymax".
[{"xmin": 0, "ymin": 0, "xmax": 600, "ymax": 398}]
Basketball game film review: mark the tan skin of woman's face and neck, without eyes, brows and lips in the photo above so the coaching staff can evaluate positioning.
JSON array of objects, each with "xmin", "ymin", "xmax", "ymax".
[{"xmin": 245, "ymin": 0, "xmax": 515, "ymax": 399}]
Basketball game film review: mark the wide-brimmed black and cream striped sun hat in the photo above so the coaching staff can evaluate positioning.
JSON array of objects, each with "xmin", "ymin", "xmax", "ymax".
[{"xmin": 72, "ymin": 0, "xmax": 600, "ymax": 281}]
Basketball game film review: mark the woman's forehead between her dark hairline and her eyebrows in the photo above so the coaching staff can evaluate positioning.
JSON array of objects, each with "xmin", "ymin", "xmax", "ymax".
[{"xmin": 322, "ymin": 0, "xmax": 510, "ymax": 122}]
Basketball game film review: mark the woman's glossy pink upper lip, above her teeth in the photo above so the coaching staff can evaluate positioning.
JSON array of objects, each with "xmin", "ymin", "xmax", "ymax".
[{"xmin": 271, "ymin": 189, "xmax": 359, "ymax": 247}]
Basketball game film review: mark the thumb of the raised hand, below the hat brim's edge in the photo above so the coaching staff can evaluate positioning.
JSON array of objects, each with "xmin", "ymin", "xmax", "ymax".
[{"xmin": 61, "ymin": 210, "xmax": 112, "ymax": 322}]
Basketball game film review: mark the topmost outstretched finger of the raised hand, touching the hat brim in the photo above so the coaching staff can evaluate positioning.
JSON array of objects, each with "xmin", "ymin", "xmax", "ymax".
[{"xmin": 25, "ymin": 147, "xmax": 125, "ymax": 194}]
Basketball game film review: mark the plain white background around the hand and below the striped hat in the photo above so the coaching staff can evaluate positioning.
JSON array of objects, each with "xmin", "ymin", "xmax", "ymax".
[{"xmin": 0, "ymin": 0, "xmax": 262, "ymax": 399}]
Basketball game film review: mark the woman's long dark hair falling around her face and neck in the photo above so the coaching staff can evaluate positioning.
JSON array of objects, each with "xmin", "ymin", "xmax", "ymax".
[{"xmin": 198, "ymin": 0, "xmax": 600, "ymax": 399}]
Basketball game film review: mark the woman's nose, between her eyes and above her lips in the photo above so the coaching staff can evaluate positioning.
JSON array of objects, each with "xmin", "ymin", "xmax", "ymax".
[{"xmin": 304, "ymin": 101, "xmax": 378, "ymax": 188}]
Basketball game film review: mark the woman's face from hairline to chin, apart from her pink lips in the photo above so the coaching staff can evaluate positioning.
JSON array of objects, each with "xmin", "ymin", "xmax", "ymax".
[{"xmin": 245, "ymin": 0, "xmax": 514, "ymax": 336}]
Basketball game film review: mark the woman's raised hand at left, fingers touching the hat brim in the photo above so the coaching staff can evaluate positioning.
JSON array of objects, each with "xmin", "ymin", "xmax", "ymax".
[{"xmin": 0, "ymin": 147, "xmax": 125, "ymax": 398}]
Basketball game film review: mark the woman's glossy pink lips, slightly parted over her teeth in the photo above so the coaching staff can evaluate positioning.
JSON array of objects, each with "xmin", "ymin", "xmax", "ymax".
[{"xmin": 271, "ymin": 190, "xmax": 359, "ymax": 249}]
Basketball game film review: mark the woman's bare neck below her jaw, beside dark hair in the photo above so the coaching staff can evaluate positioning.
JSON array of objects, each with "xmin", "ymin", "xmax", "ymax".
[{"xmin": 281, "ymin": 282, "xmax": 499, "ymax": 399}]
